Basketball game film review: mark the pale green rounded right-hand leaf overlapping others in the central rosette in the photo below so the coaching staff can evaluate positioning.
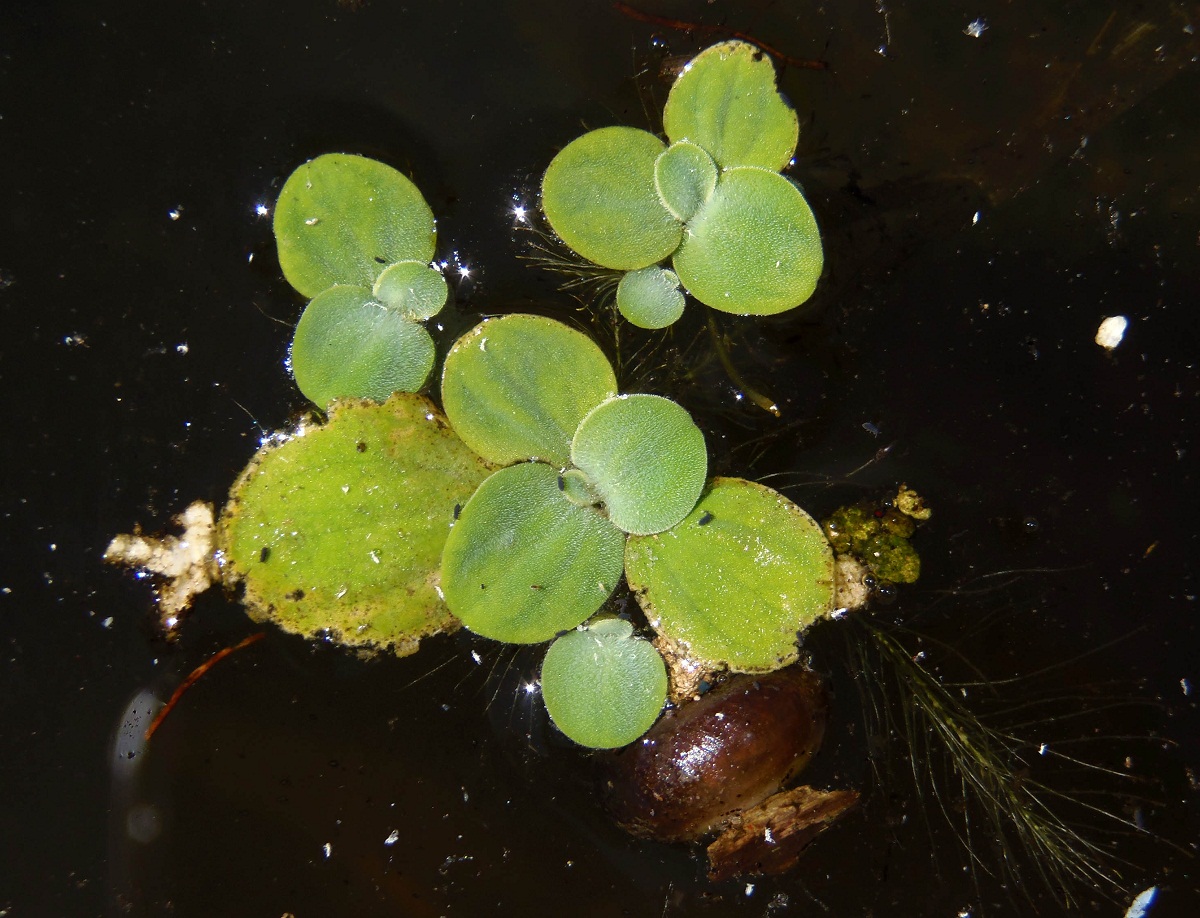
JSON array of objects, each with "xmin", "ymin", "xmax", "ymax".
[{"xmin": 571, "ymin": 395, "xmax": 708, "ymax": 535}]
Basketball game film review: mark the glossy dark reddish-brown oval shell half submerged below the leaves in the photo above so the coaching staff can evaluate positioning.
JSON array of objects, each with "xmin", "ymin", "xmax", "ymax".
[{"xmin": 600, "ymin": 666, "xmax": 828, "ymax": 841}]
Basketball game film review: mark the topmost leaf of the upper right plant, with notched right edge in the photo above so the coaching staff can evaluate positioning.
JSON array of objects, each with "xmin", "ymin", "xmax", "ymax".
[{"xmin": 662, "ymin": 41, "xmax": 799, "ymax": 172}]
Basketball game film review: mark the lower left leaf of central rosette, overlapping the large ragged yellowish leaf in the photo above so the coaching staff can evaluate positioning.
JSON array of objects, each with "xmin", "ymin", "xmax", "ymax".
[{"xmin": 442, "ymin": 462, "xmax": 624, "ymax": 643}]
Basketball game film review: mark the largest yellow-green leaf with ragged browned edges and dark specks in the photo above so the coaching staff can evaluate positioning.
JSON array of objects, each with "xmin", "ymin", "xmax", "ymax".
[{"xmin": 218, "ymin": 394, "xmax": 490, "ymax": 655}]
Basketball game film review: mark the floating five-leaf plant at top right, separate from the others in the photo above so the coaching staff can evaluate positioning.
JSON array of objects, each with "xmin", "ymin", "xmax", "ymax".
[{"xmin": 542, "ymin": 41, "xmax": 823, "ymax": 328}]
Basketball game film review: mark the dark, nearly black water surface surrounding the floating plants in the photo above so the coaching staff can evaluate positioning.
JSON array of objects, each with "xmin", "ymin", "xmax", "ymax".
[{"xmin": 0, "ymin": 0, "xmax": 1200, "ymax": 918}]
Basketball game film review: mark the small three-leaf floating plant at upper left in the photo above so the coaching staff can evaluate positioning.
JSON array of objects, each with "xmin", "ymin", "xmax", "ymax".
[{"xmin": 275, "ymin": 154, "xmax": 449, "ymax": 408}]
